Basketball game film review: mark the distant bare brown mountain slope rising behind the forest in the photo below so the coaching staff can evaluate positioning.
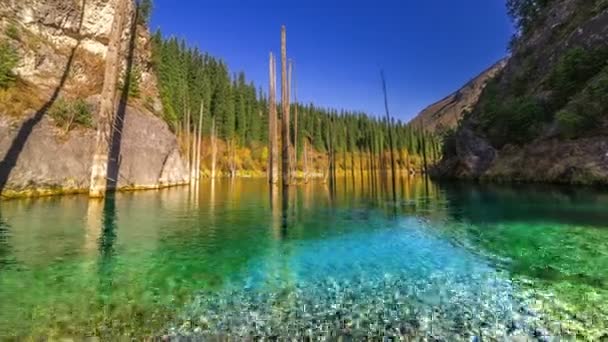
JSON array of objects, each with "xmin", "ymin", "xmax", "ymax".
[{"xmin": 410, "ymin": 60, "xmax": 507, "ymax": 132}]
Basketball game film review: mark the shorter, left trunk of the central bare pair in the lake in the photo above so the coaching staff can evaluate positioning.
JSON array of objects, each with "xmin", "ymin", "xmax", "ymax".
[{"xmin": 268, "ymin": 52, "xmax": 279, "ymax": 184}]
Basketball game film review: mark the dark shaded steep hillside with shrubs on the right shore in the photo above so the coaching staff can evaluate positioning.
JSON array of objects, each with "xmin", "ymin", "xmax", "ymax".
[{"xmin": 434, "ymin": 0, "xmax": 608, "ymax": 184}]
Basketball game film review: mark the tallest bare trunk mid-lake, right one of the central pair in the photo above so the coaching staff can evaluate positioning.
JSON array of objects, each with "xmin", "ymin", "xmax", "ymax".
[{"xmin": 281, "ymin": 26, "xmax": 291, "ymax": 186}]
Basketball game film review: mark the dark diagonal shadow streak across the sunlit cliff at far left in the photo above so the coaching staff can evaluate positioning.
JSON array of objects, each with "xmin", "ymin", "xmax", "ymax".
[{"xmin": 0, "ymin": 0, "xmax": 86, "ymax": 193}]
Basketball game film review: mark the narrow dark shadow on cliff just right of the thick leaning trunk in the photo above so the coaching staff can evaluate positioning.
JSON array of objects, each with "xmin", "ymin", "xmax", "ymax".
[{"xmin": 107, "ymin": 5, "xmax": 139, "ymax": 190}]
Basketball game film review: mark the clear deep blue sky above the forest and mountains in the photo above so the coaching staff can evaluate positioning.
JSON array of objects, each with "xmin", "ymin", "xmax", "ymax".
[{"xmin": 152, "ymin": 0, "xmax": 513, "ymax": 120}]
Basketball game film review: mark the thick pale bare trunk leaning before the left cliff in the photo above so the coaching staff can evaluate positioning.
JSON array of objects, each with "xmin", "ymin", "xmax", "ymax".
[{"xmin": 89, "ymin": 0, "xmax": 128, "ymax": 198}]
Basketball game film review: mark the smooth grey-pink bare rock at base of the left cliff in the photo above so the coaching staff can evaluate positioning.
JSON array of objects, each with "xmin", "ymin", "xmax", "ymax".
[{"xmin": 0, "ymin": 102, "xmax": 187, "ymax": 198}]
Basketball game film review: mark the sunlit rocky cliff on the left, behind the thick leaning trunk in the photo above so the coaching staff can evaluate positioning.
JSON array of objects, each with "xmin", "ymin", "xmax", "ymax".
[{"xmin": 0, "ymin": 0, "xmax": 187, "ymax": 197}]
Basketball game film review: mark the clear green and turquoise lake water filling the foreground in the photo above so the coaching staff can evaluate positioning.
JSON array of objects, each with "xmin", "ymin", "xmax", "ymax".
[{"xmin": 0, "ymin": 178, "xmax": 608, "ymax": 340}]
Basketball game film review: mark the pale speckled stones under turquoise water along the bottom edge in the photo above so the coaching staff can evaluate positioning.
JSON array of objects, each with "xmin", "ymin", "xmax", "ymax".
[{"xmin": 168, "ymin": 273, "xmax": 548, "ymax": 341}]
